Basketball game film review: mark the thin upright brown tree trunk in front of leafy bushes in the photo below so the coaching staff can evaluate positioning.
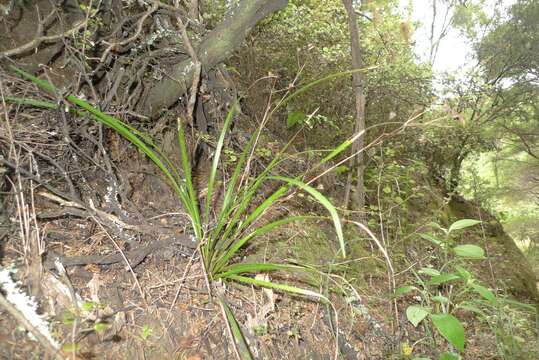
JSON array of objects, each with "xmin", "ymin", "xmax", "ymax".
[{"xmin": 342, "ymin": 0, "xmax": 365, "ymax": 220}]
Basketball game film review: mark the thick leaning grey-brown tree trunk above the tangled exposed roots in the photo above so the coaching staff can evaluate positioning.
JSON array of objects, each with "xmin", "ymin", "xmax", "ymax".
[{"xmin": 140, "ymin": 0, "xmax": 288, "ymax": 117}]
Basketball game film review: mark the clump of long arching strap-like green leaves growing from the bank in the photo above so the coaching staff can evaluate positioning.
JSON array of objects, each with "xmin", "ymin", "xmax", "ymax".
[{"xmin": 8, "ymin": 67, "xmax": 380, "ymax": 294}]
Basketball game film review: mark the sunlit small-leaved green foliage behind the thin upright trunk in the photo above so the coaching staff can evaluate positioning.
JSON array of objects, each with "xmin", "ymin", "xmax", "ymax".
[{"xmin": 234, "ymin": 0, "xmax": 431, "ymax": 149}]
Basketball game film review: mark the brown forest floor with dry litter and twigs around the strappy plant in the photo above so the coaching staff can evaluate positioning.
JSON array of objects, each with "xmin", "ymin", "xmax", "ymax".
[{"xmin": 0, "ymin": 74, "xmax": 536, "ymax": 360}]
